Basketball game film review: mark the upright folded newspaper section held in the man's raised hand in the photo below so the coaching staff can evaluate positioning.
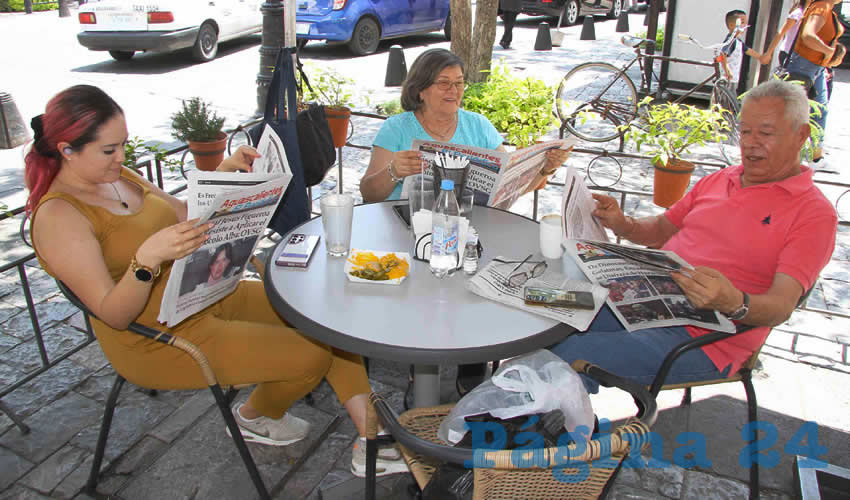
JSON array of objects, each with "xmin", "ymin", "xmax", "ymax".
[{"xmin": 561, "ymin": 167, "xmax": 608, "ymax": 244}]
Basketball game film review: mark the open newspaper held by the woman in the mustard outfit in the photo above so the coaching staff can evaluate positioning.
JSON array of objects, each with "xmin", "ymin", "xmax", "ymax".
[{"xmin": 158, "ymin": 127, "xmax": 292, "ymax": 327}]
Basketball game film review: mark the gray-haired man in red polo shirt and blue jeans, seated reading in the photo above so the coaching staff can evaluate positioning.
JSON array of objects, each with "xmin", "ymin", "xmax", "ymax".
[{"xmin": 550, "ymin": 80, "xmax": 837, "ymax": 392}]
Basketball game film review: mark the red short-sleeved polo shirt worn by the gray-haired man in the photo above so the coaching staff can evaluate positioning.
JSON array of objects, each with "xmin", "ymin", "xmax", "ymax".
[{"xmin": 663, "ymin": 165, "xmax": 838, "ymax": 373}]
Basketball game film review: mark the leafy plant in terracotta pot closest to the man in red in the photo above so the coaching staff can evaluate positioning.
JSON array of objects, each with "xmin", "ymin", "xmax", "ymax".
[{"xmin": 622, "ymin": 97, "xmax": 729, "ymax": 208}]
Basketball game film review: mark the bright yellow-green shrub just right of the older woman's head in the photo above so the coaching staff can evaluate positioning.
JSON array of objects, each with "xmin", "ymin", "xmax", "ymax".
[{"xmin": 463, "ymin": 63, "xmax": 555, "ymax": 148}]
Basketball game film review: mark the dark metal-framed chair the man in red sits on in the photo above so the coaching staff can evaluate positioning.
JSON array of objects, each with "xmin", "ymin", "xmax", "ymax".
[{"xmin": 649, "ymin": 286, "xmax": 814, "ymax": 499}]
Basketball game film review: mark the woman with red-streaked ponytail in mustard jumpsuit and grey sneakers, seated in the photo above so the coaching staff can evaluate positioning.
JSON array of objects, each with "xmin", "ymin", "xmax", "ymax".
[{"xmin": 25, "ymin": 85, "xmax": 407, "ymax": 476}]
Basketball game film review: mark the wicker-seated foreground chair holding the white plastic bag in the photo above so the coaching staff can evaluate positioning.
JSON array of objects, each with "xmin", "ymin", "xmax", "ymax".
[{"xmin": 366, "ymin": 360, "xmax": 657, "ymax": 500}]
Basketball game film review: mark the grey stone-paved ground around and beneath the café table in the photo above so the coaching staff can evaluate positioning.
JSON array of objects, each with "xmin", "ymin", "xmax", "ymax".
[{"xmin": 0, "ymin": 6, "xmax": 850, "ymax": 499}]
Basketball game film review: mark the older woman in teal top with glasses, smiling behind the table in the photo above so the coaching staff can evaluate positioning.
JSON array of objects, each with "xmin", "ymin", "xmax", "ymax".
[{"xmin": 360, "ymin": 49, "xmax": 569, "ymax": 202}]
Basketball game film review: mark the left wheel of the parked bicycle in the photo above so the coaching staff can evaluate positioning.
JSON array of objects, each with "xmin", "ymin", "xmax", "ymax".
[{"xmin": 555, "ymin": 62, "xmax": 637, "ymax": 142}]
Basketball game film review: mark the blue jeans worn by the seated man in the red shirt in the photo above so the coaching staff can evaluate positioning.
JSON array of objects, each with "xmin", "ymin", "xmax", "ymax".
[{"xmin": 549, "ymin": 305, "xmax": 730, "ymax": 394}]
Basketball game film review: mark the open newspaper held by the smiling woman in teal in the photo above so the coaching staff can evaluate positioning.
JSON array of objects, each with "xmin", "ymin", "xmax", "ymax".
[{"xmin": 402, "ymin": 137, "xmax": 576, "ymax": 209}]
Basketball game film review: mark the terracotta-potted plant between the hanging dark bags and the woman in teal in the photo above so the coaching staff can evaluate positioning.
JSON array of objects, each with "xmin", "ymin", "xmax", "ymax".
[{"xmin": 304, "ymin": 68, "xmax": 354, "ymax": 148}]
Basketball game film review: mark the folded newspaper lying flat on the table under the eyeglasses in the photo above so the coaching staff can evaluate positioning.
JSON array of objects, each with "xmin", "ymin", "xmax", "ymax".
[{"xmin": 466, "ymin": 257, "xmax": 608, "ymax": 330}]
